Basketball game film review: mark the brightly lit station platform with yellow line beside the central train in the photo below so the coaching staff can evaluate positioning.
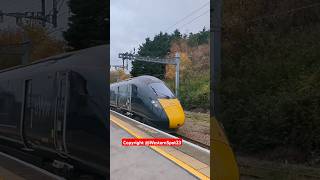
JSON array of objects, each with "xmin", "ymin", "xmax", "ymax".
[{"xmin": 110, "ymin": 114, "xmax": 210, "ymax": 180}]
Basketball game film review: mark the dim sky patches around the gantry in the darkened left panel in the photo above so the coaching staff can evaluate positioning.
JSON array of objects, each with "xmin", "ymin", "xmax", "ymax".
[{"xmin": 0, "ymin": 0, "xmax": 70, "ymax": 39}]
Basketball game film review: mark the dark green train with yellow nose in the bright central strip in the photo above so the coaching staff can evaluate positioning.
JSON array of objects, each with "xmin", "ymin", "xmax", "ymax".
[{"xmin": 110, "ymin": 75, "xmax": 185, "ymax": 132}]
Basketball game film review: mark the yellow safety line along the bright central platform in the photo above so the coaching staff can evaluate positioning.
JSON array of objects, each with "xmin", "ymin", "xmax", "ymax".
[{"xmin": 110, "ymin": 118, "xmax": 210, "ymax": 179}]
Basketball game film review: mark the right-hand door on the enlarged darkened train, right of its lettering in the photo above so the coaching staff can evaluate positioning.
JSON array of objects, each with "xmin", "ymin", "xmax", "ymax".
[{"xmin": 54, "ymin": 72, "xmax": 69, "ymax": 153}]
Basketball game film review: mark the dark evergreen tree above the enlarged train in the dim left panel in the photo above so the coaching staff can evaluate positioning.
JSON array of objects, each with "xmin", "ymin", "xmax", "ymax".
[{"xmin": 63, "ymin": 0, "xmax": 110, "ymax": 49}]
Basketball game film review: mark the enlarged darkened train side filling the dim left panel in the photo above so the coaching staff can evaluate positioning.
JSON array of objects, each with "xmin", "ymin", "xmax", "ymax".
[{"xmin": 0, "ymin": 45, "xmax": 110, "ymax": 179}]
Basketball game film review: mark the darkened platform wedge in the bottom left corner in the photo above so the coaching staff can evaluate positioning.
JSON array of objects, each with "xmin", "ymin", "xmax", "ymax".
[{"xmin": 0, "ymin": 152, "xmax": 63, "ymax": 180}]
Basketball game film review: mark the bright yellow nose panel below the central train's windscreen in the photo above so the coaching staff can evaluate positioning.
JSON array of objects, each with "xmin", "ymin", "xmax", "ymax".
[{"xmin": 159, "ymin": 99, "xmax": 185, "ymax": 129}]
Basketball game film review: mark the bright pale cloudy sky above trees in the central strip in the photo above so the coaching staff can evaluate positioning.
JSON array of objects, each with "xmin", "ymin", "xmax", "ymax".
[{"xmin": 110, "ymin": 0, "xmax": 210, "ymax": 70}]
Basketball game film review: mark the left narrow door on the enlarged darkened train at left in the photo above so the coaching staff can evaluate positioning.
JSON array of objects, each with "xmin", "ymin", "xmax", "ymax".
[{"xmin": 20, "ymin": 79, "xmax": 34, "ymax": 150}]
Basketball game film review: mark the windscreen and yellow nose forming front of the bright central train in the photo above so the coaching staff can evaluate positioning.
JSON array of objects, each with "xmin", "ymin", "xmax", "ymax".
[{"xmin": 148, "ymin": 82, "xmax": 185, "ymax": 129}]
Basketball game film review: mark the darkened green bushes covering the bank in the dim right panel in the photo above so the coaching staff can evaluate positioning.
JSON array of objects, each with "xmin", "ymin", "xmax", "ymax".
[{"xmin": 218, "ymin": 4, "xmax": 320, "ymax": 163}]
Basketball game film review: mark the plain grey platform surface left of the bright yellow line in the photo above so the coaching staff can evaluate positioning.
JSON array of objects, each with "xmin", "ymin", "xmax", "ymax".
[{"xmin": 110, "ymin": 122, "xmax": 197, "ymax": 180}]
